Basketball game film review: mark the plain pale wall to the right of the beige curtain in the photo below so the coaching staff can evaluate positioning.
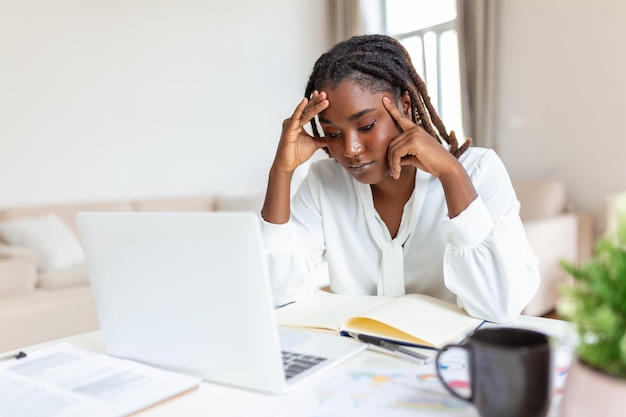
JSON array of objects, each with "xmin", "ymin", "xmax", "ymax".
[{"xmin": 497, "ymin": 0, "xmax": 626, "ymax": 229}]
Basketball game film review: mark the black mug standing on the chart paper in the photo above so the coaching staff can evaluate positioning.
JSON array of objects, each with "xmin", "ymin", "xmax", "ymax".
[{"xmin": 436, "ymin": 327, "xmax": 552, "ymax": 417}]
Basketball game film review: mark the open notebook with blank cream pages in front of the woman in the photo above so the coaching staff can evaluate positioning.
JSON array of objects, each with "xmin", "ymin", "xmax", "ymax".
[{"xmin": 276, "ymin": 292, "xmax": 483, "ymax": 348}]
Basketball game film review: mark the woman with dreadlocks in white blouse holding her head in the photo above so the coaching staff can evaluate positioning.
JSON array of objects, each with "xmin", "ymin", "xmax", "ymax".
[{"xmin": 261, "ymin": 35, "xmax": 539, "ymax": 322}]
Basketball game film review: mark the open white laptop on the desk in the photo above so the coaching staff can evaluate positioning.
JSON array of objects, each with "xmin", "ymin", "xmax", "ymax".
[{"xmin": 76, "ymin": 211, "xmax": 366, "ymax": 393}]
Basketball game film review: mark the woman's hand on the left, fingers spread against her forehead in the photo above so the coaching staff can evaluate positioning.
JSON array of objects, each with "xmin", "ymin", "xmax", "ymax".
[{"xmin": 273, "ymin": 91, "xmax": 329, "ymax": 174}]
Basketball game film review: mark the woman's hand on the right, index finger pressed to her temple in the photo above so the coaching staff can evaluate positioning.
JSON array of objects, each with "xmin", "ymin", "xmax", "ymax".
[{"xmin": 383, "ymin": 96, "xmax": 460, "ymax": 179}]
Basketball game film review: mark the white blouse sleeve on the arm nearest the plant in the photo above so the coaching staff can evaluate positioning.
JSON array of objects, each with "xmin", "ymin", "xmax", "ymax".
[{"xmin": 444, "ymin": 151, "xmax": 539, "ymax": 322}]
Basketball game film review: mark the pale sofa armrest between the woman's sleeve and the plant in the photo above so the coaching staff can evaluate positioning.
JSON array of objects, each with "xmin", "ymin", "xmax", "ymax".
[{"xmin": 523, "ymin": 214, "xmax": 579, "ymax": 316}]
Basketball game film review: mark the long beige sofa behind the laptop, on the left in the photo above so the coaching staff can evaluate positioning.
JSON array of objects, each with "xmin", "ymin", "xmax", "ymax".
[{"xmin": 0, "ymin": 195, "xmax": 262, "ymax": 352}]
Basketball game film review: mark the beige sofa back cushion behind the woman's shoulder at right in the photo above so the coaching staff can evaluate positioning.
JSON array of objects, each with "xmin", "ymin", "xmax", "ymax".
[{"xmin": 513, "ymin": 179, "xmax": 567, "ymax": 221}]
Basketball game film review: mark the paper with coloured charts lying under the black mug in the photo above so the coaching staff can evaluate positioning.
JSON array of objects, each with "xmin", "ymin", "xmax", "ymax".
[{"xmin": 231, "ymin": 346, "xmax": 572, "ymax": 417}]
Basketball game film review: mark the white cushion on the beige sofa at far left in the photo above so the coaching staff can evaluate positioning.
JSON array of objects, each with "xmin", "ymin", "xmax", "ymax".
[{"xmin": 0, "ymin": 213, "xmax": 85, "ymax": 271}]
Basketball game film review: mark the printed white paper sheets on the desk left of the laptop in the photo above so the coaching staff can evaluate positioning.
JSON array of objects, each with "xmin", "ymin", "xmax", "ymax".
[{"xmin": 0, "ymin": 344, "xmax": 200, "ymax": 417}]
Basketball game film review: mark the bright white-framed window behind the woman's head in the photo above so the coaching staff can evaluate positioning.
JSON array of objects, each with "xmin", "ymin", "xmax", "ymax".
[{"xmin": 362, "ymin": 0, "xmax": 465, "ymax": 142}]
